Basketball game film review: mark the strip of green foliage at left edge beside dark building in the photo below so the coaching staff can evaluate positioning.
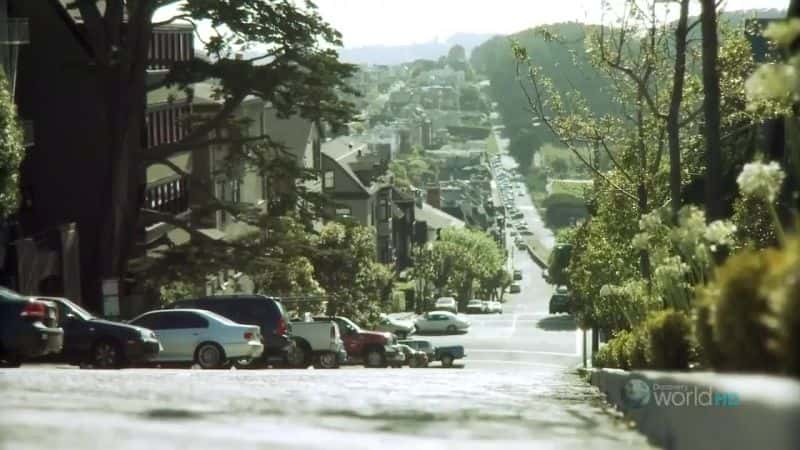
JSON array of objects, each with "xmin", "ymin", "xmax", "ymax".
[{"xmin": 0, "ymin": 72, "xmax": 25, "ymax": 220}]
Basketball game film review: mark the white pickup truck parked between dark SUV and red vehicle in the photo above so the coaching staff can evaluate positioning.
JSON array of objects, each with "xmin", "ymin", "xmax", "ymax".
[{"xmin": 287, "ymin": 320, "xmax": 347, "ymax": 369}]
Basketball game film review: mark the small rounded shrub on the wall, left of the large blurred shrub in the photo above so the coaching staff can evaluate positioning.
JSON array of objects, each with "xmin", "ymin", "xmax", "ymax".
[{"xmin": 645, "ymin": 309, "xmax": 692, "ymax": 370}]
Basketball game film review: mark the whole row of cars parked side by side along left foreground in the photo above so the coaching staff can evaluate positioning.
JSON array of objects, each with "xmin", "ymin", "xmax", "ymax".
[{"xmin": 0, "ymin": 288, "xmax": 463, "ymax": 369}]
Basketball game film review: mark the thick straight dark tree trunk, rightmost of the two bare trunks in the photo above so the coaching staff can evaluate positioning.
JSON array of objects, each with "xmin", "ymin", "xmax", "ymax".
[{"xmin": 700, "ymin": 0, "xmax": 723, "ymax": 221}]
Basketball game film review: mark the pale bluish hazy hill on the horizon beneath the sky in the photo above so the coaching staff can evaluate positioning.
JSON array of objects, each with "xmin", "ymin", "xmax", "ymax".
[{"xmin": 339, "ymin": 33, "xmax": 500, "ymax": 65}]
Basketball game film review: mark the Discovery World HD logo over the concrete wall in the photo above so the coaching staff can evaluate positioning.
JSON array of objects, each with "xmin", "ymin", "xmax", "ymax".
[{"xmin": 622, "ymin": 377, "xmax": 740, "ymax": 409}]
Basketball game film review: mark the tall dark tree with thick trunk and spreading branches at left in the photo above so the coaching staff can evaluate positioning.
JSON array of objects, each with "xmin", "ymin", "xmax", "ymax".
[{"xmin": 46, "ymin": 0, "xmax": 354, "ymax": 308}]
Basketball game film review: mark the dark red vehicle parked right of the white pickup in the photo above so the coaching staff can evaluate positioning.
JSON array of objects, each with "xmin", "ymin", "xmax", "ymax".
[{"xmin": 314, "ymin": 316, "xmax": 405, "ymax": 367}]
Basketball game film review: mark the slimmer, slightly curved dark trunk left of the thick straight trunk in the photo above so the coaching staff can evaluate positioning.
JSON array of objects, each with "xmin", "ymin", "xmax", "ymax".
[{"xmin": 667, "ymin": 0, "xmax": 689, "ymax": 223}]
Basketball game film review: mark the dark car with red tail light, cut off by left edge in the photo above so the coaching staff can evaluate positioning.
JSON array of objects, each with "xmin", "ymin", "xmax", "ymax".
[{"xmin": 0, "ymin": 287, "xmax": 64, "ymax": 367}]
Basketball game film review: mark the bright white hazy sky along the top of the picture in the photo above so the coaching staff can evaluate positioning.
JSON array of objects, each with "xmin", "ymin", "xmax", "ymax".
[{"xmin": 315, "ymin": 0, "xmax": 789, "ymax": 47}]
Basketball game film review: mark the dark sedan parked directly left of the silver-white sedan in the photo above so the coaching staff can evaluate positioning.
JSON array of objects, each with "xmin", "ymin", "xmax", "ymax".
[{"xmin": 38, "ymin": 297, "xmax": 161, "ymax": 369}]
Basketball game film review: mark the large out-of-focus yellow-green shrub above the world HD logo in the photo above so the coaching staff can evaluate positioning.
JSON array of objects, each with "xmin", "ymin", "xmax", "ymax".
[{"xmin": 701, "ymin": 249, "xmax": 782, "ymax": 372}]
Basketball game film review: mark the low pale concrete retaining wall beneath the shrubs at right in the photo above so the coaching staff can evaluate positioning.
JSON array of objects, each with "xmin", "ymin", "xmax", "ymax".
[{"xmin": 588, "ymin": 369, "xmax": 800, "ymax": 450}]
